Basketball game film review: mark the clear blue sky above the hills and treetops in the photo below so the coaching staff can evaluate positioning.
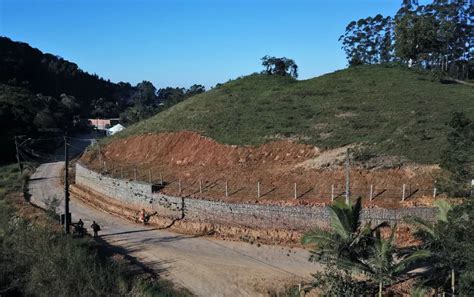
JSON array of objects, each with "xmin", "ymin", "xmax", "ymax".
[{"xmin": 0, "ymin": 0, "xmax": 401, "ymax": 88}]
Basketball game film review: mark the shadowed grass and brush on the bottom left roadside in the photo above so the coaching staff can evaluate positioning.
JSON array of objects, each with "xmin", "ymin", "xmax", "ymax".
[{"xmin": 0, "ymin": 165, "xmax": 190, "ymax": 296}]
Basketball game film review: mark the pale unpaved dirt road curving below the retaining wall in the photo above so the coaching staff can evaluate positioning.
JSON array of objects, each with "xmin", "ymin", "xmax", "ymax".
[{"xmin": 29, "ymin": 162, "xmax": 320, "ymax": 296}]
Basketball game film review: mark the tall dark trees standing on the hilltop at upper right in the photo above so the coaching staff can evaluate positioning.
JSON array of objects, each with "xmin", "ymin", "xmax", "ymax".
[{"xmin": 339, "ymin": 0, "xmax": 474, "ymax": 79}]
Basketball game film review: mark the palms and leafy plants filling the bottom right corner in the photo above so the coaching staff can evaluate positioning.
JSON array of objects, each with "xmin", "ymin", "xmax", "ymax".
[{"xmin": 302, "ymin": 200, "xmax": 474, "ymax": 296}]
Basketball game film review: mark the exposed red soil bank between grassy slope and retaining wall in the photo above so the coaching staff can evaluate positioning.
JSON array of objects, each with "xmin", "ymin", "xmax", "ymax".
[{"xmin": 82, "ymin": 132, "xmax": 436, "ymax": 207}]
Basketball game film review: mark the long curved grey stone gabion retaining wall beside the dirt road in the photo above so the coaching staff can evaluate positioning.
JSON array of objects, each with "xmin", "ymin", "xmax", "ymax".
[{"xmin": 76, "ymin": 163, "xmax": 436, "ymax": 231}]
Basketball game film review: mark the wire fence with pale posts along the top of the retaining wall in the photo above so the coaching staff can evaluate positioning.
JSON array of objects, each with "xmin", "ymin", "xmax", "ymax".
[{"xmin": 88, "ymin": 159, "xmax": 439, "ymax": 201}]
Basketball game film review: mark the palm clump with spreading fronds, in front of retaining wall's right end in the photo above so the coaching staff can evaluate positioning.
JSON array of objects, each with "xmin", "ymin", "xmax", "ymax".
[{"xmin": 302, "ymin": 198, "xmax": 429, "ymax": 296}]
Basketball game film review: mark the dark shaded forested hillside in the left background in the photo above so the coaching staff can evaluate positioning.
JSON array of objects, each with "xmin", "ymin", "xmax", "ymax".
[{"xmin": 0, "ymin": 37, "xmax": 205, "ymax": 163}]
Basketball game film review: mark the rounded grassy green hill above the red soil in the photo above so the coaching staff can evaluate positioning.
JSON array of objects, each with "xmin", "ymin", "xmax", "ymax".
[{"xmin": 117, "ymin": 65, "xmax": 474, "ymax": 163}]
